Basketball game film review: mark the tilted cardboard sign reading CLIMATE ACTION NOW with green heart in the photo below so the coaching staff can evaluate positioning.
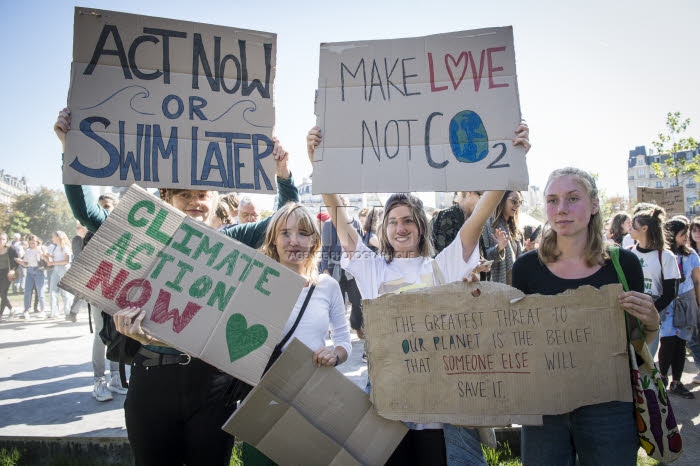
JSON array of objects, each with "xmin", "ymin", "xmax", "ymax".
[{"xmin": 59, "ymin": 185, "xmax": 304, "ymax": 384}]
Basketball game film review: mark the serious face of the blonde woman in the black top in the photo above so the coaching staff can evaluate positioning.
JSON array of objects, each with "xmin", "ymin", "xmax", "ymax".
[{"xmin": 545, "ymin": 175, "xmax": 598, "ymax": 237}]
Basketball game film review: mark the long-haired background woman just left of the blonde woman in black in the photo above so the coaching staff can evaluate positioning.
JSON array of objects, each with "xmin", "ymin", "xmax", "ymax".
[{"xmin": 481, "ymin": 191, "xmax": 523, "ymax": 285}]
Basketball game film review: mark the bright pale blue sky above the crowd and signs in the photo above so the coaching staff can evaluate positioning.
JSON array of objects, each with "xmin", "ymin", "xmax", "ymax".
[{"xmin": 0, "ymin": 0, "xmax": 700, "ymax": 208}]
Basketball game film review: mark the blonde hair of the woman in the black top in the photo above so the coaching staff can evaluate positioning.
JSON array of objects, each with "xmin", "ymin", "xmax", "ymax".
[{"xmin": 537, "ymin": 167, "xmax": 609, "ymax": 267}]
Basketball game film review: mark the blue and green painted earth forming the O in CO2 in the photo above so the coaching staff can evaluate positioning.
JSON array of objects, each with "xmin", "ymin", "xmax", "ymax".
[{"xmin": 450, "ymin": 110, "xmax": 489, "ymax": 163}]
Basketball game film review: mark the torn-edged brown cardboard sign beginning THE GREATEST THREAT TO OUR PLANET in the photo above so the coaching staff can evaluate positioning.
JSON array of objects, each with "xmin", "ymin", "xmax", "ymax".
[{"xmin": 362, "ymin": 282, "xmax": 632, "ymax": 425}]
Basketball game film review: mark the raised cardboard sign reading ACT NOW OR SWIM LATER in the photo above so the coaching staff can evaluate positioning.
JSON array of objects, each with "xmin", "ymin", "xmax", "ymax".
[{"xmin": 63, "ymin": 7, "xmax": 277, "ymax": 193}]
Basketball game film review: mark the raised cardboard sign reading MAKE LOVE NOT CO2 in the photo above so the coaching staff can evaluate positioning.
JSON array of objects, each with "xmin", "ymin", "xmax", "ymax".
[{"xmin": 313, "ymin": 27, "xmax": 528, "ymax": 193}]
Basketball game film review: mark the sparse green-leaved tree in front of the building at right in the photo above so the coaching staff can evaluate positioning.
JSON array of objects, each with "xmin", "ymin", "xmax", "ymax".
[{"xmin": 651, "ymin": 112, "xmax": 700, "ymax": 186}]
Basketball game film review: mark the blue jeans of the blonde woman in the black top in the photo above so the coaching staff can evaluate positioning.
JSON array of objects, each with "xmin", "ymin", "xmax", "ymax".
[{"xmin": 520, "ymin": 401, "xmax": 639, "ymax": 466}]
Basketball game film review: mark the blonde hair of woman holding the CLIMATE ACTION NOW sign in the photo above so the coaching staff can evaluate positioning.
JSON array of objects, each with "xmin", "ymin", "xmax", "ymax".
[{"xmin": 262, "ymin": 202, "xmax": 321, "ymax": 283}]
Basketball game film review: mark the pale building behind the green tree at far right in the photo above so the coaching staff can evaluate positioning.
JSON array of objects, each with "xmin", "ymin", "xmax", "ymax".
[{"xmin": 627, "ymin": 146, "xmax": 700, "ymax": 217}]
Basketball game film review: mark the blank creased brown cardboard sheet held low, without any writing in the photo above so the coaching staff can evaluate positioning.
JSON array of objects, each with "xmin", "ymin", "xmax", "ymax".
[{"xmin": 223, "ymin": 338, "xmax": 408, "ymax": 466}]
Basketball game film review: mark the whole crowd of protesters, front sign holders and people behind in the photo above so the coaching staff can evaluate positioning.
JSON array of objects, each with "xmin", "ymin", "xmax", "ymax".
[{"xmin": 0, "ymin": 105, "xmax": 700, "ymax": 465}]
